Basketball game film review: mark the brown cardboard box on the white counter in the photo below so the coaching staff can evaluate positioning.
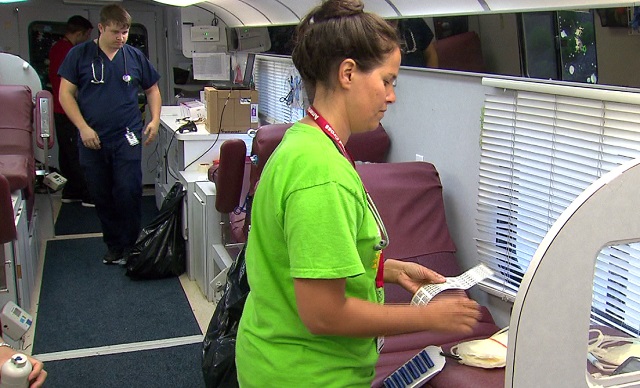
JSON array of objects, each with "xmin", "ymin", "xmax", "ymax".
[{"xmin": 204, "ymin": 87, "xmax": 259, "ymax": 133}]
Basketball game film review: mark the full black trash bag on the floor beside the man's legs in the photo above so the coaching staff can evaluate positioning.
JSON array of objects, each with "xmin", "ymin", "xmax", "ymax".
[{"xmin": 126, "ymin": 182, "xmax": 186, "ymax": 279}]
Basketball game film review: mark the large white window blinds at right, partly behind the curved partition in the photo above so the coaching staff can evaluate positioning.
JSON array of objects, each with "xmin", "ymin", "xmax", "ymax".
[{"xmin": 476, "ymin": 78, "xmax": 640, "ymax": 334}]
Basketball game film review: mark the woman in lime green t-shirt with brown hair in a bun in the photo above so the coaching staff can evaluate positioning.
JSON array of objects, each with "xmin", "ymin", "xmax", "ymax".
[{"xmin": 236, "ymin": 0, "xmax": 480, "ymax": 387}]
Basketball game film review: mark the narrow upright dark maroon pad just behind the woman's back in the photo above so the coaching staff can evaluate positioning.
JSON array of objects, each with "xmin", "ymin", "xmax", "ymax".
[{"xmin": 213, "ymin": 139, "xmax": 247, "ymax": 213}]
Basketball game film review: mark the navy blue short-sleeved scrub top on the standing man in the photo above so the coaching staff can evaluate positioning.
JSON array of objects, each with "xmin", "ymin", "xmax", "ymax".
[{"xmin": 58, "ymin": 40, "xmax": 160, "ymax": 142}]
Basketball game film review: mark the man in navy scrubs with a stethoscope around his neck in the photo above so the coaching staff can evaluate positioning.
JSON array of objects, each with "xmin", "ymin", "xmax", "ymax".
[{"xmin": 58, "ymin": 4, "xmax": 162, "ymax": 264}]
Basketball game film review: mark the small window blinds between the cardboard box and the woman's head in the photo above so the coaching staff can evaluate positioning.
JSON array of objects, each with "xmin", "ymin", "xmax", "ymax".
[{"xmin": 254, "ymin": 56, "xmax": 304, "ymax": 124}]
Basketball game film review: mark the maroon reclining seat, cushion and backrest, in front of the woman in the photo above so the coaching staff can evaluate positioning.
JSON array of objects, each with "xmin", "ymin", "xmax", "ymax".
[{"xmin": 358, "ymin": 162, "xmax": 504, "ymax": 388}]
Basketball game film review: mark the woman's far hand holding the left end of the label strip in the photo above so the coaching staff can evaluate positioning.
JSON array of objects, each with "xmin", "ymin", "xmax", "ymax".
[{"xmin": 384, "ymin": 259, "xmax": 446, "ymax": 294}]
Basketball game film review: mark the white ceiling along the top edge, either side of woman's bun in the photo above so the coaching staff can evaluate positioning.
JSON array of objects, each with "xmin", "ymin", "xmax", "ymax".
[{"xmin": 191, "ymin": 0, "xmax": 634, "ymax": 27}]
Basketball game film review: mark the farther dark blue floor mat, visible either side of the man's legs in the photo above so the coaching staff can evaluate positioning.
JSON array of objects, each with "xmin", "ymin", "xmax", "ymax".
[{"xmin": 55, "ymin": 195, "xmax": 158, "ymax": 236}]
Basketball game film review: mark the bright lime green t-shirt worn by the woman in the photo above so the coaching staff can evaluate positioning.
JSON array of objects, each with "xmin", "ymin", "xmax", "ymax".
[{"xmin": 236, "ymin": 123, "xmax": 381, "ymax": 388}]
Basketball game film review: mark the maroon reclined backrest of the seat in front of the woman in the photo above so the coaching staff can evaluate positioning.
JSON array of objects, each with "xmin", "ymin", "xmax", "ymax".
[{"xmin": 356, "ymin": 162, "xmax": 456, "ymax": 259}]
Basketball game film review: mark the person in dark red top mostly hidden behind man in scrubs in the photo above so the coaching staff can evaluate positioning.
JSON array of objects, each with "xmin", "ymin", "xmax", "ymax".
[{"xmin": 49, "ymin": 15, "xmax": 93, "ymax": 207}]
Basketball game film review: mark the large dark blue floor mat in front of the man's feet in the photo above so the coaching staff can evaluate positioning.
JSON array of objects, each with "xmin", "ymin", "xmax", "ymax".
[{"xmin": 32, "ymin": 238, "xmax": 201, "ymax": 354}]
